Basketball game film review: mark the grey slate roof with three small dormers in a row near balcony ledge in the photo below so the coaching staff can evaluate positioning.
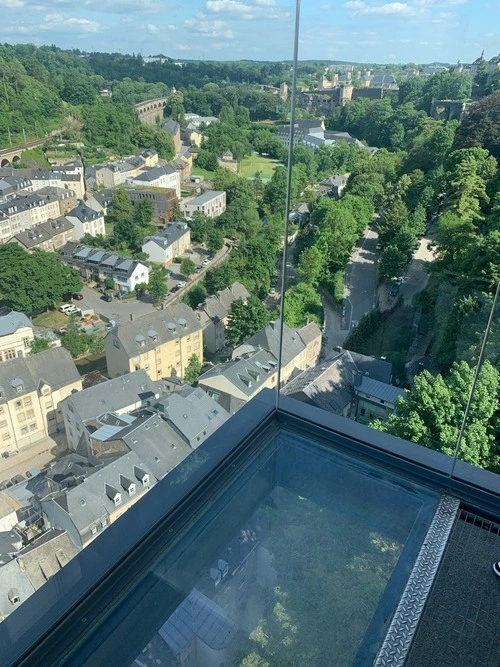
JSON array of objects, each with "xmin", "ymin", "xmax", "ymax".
[{"xmin": 49, "ymin": 452, "xmax": 155, "ymax": 533}]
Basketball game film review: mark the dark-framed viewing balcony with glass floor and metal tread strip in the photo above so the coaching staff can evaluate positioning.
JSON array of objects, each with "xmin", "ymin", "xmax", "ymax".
[{"xmin": 0, "ymin": 390, "xmax": 500, "ymax": 667}]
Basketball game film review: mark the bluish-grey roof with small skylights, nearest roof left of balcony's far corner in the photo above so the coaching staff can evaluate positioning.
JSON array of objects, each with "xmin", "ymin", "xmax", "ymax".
[{"xmin": 156, "ymin": 387, "xmax": 229, "ymax": 448}]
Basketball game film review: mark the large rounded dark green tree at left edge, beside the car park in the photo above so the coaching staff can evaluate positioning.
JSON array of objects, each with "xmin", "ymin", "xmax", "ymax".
[{"xmin": 0, "ymin": 243, "xmax": 81, "ymax": 314}]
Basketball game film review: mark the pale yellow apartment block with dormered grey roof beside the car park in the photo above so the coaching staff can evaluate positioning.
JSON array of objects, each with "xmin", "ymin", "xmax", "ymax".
[{"xmin": 104, "ymin": 303, "xmax": 203, "ymax": 381}]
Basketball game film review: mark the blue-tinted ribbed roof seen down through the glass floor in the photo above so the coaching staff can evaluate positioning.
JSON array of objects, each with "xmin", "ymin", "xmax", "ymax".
[{"xmin": 158, "ymin": 588, "xmax": 238, "ymax": 655}]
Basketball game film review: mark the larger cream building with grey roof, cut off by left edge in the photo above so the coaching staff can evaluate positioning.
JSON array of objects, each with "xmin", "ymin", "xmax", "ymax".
[{"xmin": 0, "ymin": 347, "xmax": 82, "ymax": 454}]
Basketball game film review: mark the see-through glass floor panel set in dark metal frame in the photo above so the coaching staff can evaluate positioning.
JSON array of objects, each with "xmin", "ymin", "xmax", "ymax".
[{"xmin": 60, "ymin": 431, "xmax": 439, "ymax": 667}]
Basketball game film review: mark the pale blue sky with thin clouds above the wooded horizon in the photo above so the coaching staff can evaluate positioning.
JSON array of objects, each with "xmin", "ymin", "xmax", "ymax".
[{"xmin": 0, "ymin": 0, "xmax": 500, "ymax": 63}]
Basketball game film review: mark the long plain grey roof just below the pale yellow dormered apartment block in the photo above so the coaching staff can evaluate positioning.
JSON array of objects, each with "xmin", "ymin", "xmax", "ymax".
[{"xmin": 61, "ymin": 370, "xmax": 160, "ymax": 422}]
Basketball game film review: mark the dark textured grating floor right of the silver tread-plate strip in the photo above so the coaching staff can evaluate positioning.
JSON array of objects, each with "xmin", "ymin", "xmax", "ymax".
[{"xmin": 405, "ymin": 510, "xmax": 500, "ymax": 667}]
